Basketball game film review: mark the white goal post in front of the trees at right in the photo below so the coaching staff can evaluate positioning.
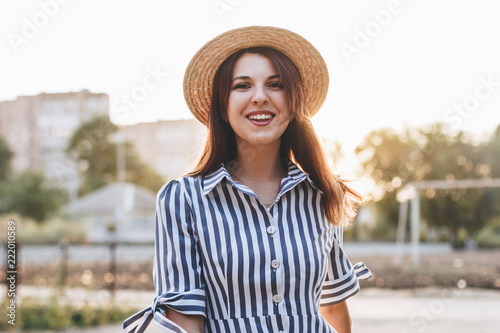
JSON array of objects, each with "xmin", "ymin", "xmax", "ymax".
[{"xmin": 396, "ymin": 178, "xmax": 500, "ymax": 266}]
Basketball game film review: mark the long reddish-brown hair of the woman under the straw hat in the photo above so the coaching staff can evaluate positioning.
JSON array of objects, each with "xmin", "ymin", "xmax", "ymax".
[{"xmin": 188, "ymin": 47, "xmax": 361, "ymax": 225}]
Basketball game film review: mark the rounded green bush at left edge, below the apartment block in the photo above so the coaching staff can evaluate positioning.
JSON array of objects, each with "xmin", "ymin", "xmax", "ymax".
[{"xmin": 0, "ymin": 170, "xmax": 65, "ymax": 222}]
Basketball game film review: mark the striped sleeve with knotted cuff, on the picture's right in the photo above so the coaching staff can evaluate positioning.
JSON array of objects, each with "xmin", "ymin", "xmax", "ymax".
[{"xmin": 320, "ymin": 227, "xmax": 372, "ymax": 306}]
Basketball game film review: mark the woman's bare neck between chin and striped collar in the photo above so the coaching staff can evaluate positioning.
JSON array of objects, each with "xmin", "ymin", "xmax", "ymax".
[{"xmin": 231, "ymin": 141, "xmax": 283, "ymax": 182}]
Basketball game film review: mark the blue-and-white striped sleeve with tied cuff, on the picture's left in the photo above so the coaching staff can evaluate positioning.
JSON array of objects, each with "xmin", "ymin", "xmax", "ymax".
[{"xmin": 123, "ymin": 181, "xmax": 206, "ymax": 333}]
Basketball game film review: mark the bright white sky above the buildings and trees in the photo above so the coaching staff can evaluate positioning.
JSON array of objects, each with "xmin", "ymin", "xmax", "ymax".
[{"xmin": 0, "ymin": 0, "xmax": 500, "ymax": 166}]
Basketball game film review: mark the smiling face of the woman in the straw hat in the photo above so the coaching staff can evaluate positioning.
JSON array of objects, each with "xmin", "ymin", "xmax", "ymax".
[{"xmin": 227, "ymin": 53, "xmax": 290, "ymax": 145}]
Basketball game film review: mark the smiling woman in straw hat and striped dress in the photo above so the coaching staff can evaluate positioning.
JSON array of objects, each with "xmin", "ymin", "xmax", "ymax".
[{"xmin": 124, "ymin": 27, "xmax": 371, "ymax": 333}]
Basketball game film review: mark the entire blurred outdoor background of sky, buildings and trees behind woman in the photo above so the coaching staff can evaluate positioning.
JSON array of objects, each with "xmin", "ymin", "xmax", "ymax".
[{"xmin": 0, "ymin": 0, "xmax": 500, "ymax": 332}]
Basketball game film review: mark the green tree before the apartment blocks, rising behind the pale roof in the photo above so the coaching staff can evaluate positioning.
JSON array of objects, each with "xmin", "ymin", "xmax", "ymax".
[{"xmin": 67, "ymin": 116, "xmax": 164, "ymax": 195}]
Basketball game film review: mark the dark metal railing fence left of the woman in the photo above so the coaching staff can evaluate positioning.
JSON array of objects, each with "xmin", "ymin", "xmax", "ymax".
[{"xmin": 0, "ymin": 241, "xmax": 154, "ymax": 292}]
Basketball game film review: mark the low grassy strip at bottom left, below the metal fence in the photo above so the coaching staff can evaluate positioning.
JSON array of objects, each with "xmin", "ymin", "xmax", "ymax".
[{"xmin": 0, "ymin": 296, "xmax": 136, "ymax": 330}]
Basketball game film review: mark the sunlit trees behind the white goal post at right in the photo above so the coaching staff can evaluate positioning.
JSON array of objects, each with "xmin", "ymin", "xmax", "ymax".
[{"xmin": 356, "ymin": 124, "xmax": 500, "ymax": 245}]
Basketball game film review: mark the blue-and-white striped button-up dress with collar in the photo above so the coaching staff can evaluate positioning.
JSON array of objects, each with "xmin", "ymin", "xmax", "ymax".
[{"xmin": 123, "ymin": 162, "xmax": 371, "ymax": 333}]
